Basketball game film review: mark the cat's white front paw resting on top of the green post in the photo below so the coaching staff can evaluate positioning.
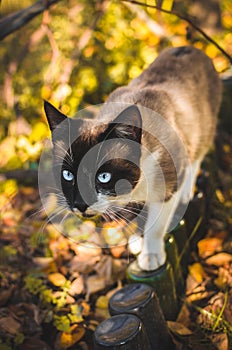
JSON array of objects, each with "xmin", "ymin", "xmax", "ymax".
[{"xmin": 138, "ymin": 253, "xmax": 166, "ymax": 271}]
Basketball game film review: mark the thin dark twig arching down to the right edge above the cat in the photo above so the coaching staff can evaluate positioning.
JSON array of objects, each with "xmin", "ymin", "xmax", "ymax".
[{"xmin": 122, "ymin": 0, "xmax": 232, "ymax": 64}]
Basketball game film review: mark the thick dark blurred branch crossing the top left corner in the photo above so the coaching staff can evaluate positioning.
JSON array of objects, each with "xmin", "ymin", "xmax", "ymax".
[{"xmin": 0, "ymin": 0, "xmax": 60, "ymax": 40}]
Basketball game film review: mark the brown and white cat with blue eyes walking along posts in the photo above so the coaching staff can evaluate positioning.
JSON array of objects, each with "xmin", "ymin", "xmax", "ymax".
[{"xmin": 45, "ymin": 46, "xmax": 221, "ymax": 271}]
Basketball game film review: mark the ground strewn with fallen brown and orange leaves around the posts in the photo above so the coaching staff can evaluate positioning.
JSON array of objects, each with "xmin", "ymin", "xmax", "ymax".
[{"xmin": 0, "ymin": 91, "xmax": 232, "ymax": 350}]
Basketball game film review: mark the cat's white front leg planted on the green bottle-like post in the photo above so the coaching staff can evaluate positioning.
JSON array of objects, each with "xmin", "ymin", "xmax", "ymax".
[{"xmin": 138, "ymin": 190, "xmax": 182, "ymax": 271}]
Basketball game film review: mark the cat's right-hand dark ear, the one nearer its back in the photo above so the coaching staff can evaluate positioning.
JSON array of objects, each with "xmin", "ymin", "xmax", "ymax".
[{"xmin": 111, "ymin": 105, "xmax": 142, "ymax": 143}]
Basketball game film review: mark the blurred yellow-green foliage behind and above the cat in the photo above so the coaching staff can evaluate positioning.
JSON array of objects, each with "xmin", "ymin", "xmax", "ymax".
[{"xmin": 0, "ymin": 0, "xmax": 232, "ymax": 170}]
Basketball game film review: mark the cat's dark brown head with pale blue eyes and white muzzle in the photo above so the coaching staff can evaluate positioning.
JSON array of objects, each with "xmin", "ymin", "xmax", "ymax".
[{"xmin": 45, "ymin": 102, "xmax": 142, "ymax": 220}]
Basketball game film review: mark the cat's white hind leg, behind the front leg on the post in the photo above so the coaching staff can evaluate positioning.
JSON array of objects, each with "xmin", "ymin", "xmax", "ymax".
[{"xmin": 181, "ymin": 159, "xmax": 201, "ymax": 204}]
